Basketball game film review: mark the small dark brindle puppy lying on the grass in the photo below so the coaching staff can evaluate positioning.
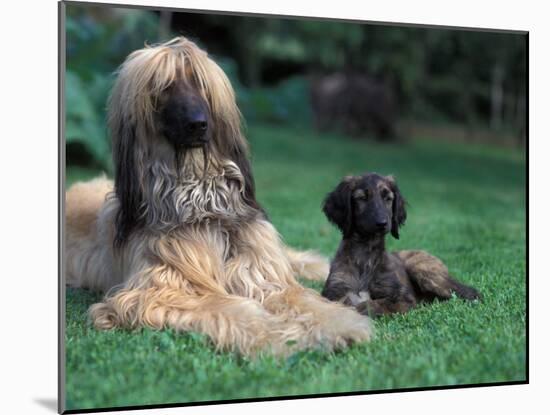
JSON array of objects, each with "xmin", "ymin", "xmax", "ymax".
[{"xmin": 323, "ymin": 173, "xmax": 480, "ymax": 316}]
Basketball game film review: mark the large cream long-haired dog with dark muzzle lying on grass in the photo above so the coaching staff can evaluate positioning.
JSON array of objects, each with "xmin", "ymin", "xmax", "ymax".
[{"xmin": 65, "ymin": 37, "xmax": 371, "ymax": 354}]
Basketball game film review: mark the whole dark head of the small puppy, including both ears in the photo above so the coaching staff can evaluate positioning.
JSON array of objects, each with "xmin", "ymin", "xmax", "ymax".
[{"xmin": 323, "ymin": 173, "xmax": 406, "ymax": 238}]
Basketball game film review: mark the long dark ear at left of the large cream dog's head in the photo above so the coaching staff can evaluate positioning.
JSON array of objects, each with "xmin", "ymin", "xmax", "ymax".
[{"xmin": 113, "ymin": 122, "xmax": 143, "ymax": 247}]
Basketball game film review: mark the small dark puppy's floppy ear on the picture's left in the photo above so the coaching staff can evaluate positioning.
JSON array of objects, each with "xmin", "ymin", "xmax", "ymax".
[{"xmin": 323, "ymin": 176, "xmax": 356, "ymax": 237}]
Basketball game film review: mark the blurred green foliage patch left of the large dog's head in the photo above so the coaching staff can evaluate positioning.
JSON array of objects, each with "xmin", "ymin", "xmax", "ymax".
[{"xmin": 65, "ymin": 5, "xmax": 163, "ymax": 169}]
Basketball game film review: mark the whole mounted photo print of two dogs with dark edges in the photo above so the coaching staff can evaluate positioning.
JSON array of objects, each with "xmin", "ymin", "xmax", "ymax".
[{"xmin": 59, "ymin": 1, "xmax": 528, "ymax": 413}]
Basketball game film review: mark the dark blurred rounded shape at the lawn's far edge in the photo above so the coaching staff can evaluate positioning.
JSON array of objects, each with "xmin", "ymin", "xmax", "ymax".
[{"xmin": 311, "ymin": 73, "xmax": 396, "ymax": 139}]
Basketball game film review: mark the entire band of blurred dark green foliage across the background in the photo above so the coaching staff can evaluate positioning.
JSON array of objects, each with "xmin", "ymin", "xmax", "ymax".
[{"xmin": 65, "ymin": 3, "xmax": 527, "ymax": 170}]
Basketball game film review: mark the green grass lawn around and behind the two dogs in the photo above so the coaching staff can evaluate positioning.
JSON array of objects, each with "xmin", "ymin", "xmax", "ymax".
[{"xmin": 66, "ymin": 122, "xmax": 526, "ymax": 409}]
